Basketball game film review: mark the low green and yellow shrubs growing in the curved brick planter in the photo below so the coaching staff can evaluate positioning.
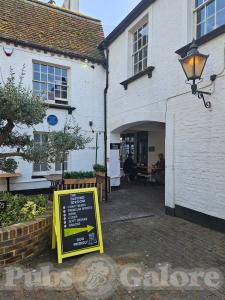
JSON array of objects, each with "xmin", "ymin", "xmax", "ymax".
[{"xmin": 0, "ymin": 193, "xmax": 48, "ymax": 227}]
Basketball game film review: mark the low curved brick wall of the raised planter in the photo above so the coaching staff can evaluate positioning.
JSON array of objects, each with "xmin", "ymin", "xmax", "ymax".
[{"xmin": 0, "ymin": 210, "xmax": 52, "ymax": 267}]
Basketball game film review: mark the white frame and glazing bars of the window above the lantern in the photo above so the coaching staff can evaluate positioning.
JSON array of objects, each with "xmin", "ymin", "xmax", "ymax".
[{"xmin": 194, "ymin": 0, "xmax": 225, "ymax": 38}]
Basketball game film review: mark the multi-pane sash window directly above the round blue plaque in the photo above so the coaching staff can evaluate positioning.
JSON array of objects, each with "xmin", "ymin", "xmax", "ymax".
[{"xmin": 33, "ymin": 62, "xmax": 68, "ymax": 104}]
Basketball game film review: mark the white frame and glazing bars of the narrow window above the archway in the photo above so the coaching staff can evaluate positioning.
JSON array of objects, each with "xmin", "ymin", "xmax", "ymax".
[{"xmin": 132, "ymin": 20, "xmax": 149, "ymax": 75}]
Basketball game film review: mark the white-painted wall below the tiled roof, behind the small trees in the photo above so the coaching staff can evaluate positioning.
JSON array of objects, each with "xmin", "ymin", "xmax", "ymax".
[{"xmin": 0, "ymin": 43, "xmax": 105, "ymax": 190}]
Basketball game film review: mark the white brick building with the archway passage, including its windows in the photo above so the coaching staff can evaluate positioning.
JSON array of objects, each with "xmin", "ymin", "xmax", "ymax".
[{"xmin": 103, "ymin": 0, "xmax": 225, "ymax": 229}]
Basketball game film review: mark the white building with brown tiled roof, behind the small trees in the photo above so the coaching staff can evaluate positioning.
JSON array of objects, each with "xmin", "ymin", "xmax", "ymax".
[{"xmin": 0, "ymin": 0, "xmax": 105, "ymax": 190}]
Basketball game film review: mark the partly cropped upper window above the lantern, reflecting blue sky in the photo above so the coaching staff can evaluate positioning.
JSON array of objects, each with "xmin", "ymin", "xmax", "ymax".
[{"xmin": 195, "ymin": 0, "xmax": 225, "ymax": 38}]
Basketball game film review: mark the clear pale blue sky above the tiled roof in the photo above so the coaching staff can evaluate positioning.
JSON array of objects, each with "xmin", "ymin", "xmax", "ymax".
[{"xmin": 42, "ymin": 0, "xmax": 140, "ymax": 36}]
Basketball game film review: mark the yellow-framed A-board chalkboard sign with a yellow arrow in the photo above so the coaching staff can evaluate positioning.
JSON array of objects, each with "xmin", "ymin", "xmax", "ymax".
[{"xmin": 52, "ymin": 188, "xmax": 103, "ymax": 263}]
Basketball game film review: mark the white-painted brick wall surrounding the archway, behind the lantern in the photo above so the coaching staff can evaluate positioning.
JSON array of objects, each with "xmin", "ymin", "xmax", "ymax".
[{"xmin": 108, "ymin": 0, "xmax": 225, "ymax": 219}]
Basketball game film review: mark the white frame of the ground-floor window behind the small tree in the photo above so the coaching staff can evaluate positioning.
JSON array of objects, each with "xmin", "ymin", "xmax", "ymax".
[{"xmin": 32, "ymin": 131, "xmax": 69, "ymax": 176}]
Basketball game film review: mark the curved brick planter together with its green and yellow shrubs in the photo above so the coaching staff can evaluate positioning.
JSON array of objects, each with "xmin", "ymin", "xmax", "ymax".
[{"xmin": 0, "ymin": 193, "xmax": 52, "ymax": 267}]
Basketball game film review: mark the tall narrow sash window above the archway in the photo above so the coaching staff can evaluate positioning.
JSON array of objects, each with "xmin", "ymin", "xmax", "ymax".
[{"xmin": 133, "ymin": 23, "xmax": 148, "ymax": 75}]
